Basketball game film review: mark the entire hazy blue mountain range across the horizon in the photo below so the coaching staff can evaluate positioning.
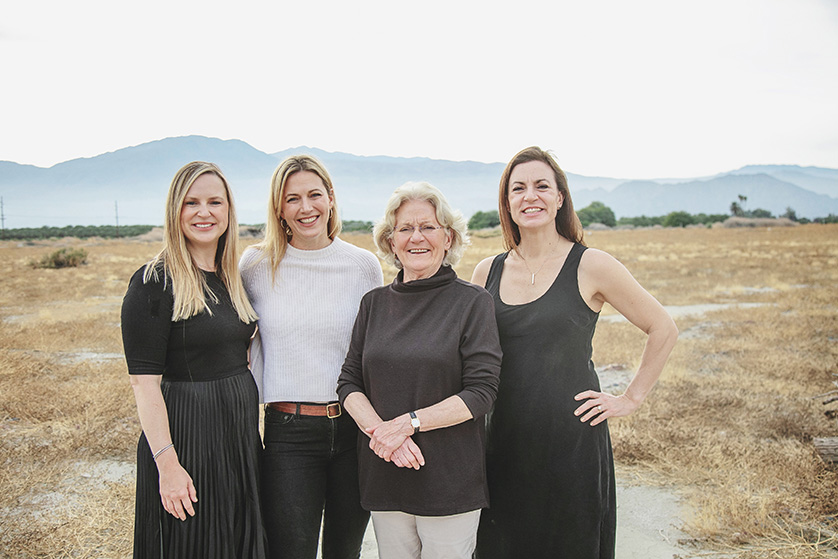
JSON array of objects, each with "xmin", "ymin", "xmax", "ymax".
[{"xmin": 0, "ymin": 136, "xmax": 838, "ymax": 228}]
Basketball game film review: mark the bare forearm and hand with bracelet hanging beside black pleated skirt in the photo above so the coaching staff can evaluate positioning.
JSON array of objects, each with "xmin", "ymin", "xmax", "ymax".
[{"xmin": 130, "ymin": 375, "xmax": 198, "ymax": 520}]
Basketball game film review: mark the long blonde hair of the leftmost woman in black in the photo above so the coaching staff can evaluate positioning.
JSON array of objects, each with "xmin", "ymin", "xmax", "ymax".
[{"xmin": 143, "ymin": 161, "xmax": 257, "ymax": 323}]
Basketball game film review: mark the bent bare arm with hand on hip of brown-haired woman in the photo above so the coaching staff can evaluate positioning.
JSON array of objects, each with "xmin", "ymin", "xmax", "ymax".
[{"xmin": 575, "ymin": 249, "xmax": 678, "ymax": 425}]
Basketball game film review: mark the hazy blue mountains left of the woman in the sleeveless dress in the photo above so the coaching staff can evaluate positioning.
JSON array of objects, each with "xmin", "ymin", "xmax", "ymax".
[{"xmin": 0, "ymin": 136, "xmax": 503, "ymax": 228}]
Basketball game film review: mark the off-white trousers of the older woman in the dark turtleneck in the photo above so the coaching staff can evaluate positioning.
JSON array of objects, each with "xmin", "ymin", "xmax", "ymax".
[{"xmin": 371, "ymin": 510, "xmax": 480, "ymax": 559}]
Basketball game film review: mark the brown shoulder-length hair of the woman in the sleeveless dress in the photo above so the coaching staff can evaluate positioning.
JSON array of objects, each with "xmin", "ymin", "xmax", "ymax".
[{"xmin": 498, "ymin": 146, "xmax": 585, "ymax": 250}]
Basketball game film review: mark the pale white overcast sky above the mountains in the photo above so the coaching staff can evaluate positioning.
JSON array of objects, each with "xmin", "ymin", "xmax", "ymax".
[{"xmin": 0, "ymin": 0, "xmax": 838, "ymax": 179}]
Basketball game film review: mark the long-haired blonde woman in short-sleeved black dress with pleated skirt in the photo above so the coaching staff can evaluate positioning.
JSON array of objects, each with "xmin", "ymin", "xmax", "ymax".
[{"xmin": 122, "ymin": 162, "xmax": 265, "ymax": 559}]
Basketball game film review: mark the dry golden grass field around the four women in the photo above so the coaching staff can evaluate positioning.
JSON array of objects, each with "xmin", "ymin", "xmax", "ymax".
[{"xmin": 0, "ymin": 225, "xmax": 838, "ymax": 559}]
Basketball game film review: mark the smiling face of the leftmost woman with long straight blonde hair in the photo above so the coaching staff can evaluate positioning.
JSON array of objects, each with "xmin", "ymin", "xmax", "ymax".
[{"xmin": 180, "ymin": 173, "xmax": 230, "ymax": 255}]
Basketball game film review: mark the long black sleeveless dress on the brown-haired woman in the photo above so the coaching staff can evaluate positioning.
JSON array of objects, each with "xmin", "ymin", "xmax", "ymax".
[{"xmin": 477, "ymin": 244, "xmax": 617, "ymax": 559}]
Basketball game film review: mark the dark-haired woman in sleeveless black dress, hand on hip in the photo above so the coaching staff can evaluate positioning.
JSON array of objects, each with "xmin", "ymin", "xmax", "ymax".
[{"xmin": 472, "ymin": 147, "xmax": 678, "ymax": 559}]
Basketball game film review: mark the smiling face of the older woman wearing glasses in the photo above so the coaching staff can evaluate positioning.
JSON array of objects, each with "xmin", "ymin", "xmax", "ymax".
[{"xmin": 390, "ymin": 200, "xmax": 452, "ymax": 281}]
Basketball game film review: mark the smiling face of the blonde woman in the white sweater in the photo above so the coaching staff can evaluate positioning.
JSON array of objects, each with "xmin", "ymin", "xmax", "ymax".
[{"xmin": 279, "ymin": 171, "xmax": 333, "ymax": 250}]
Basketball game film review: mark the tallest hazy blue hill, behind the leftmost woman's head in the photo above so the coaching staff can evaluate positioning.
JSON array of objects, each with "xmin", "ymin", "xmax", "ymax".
[{"xmin": 0, "ymin": 136, "xmax": 276, "ymax": 228}]
